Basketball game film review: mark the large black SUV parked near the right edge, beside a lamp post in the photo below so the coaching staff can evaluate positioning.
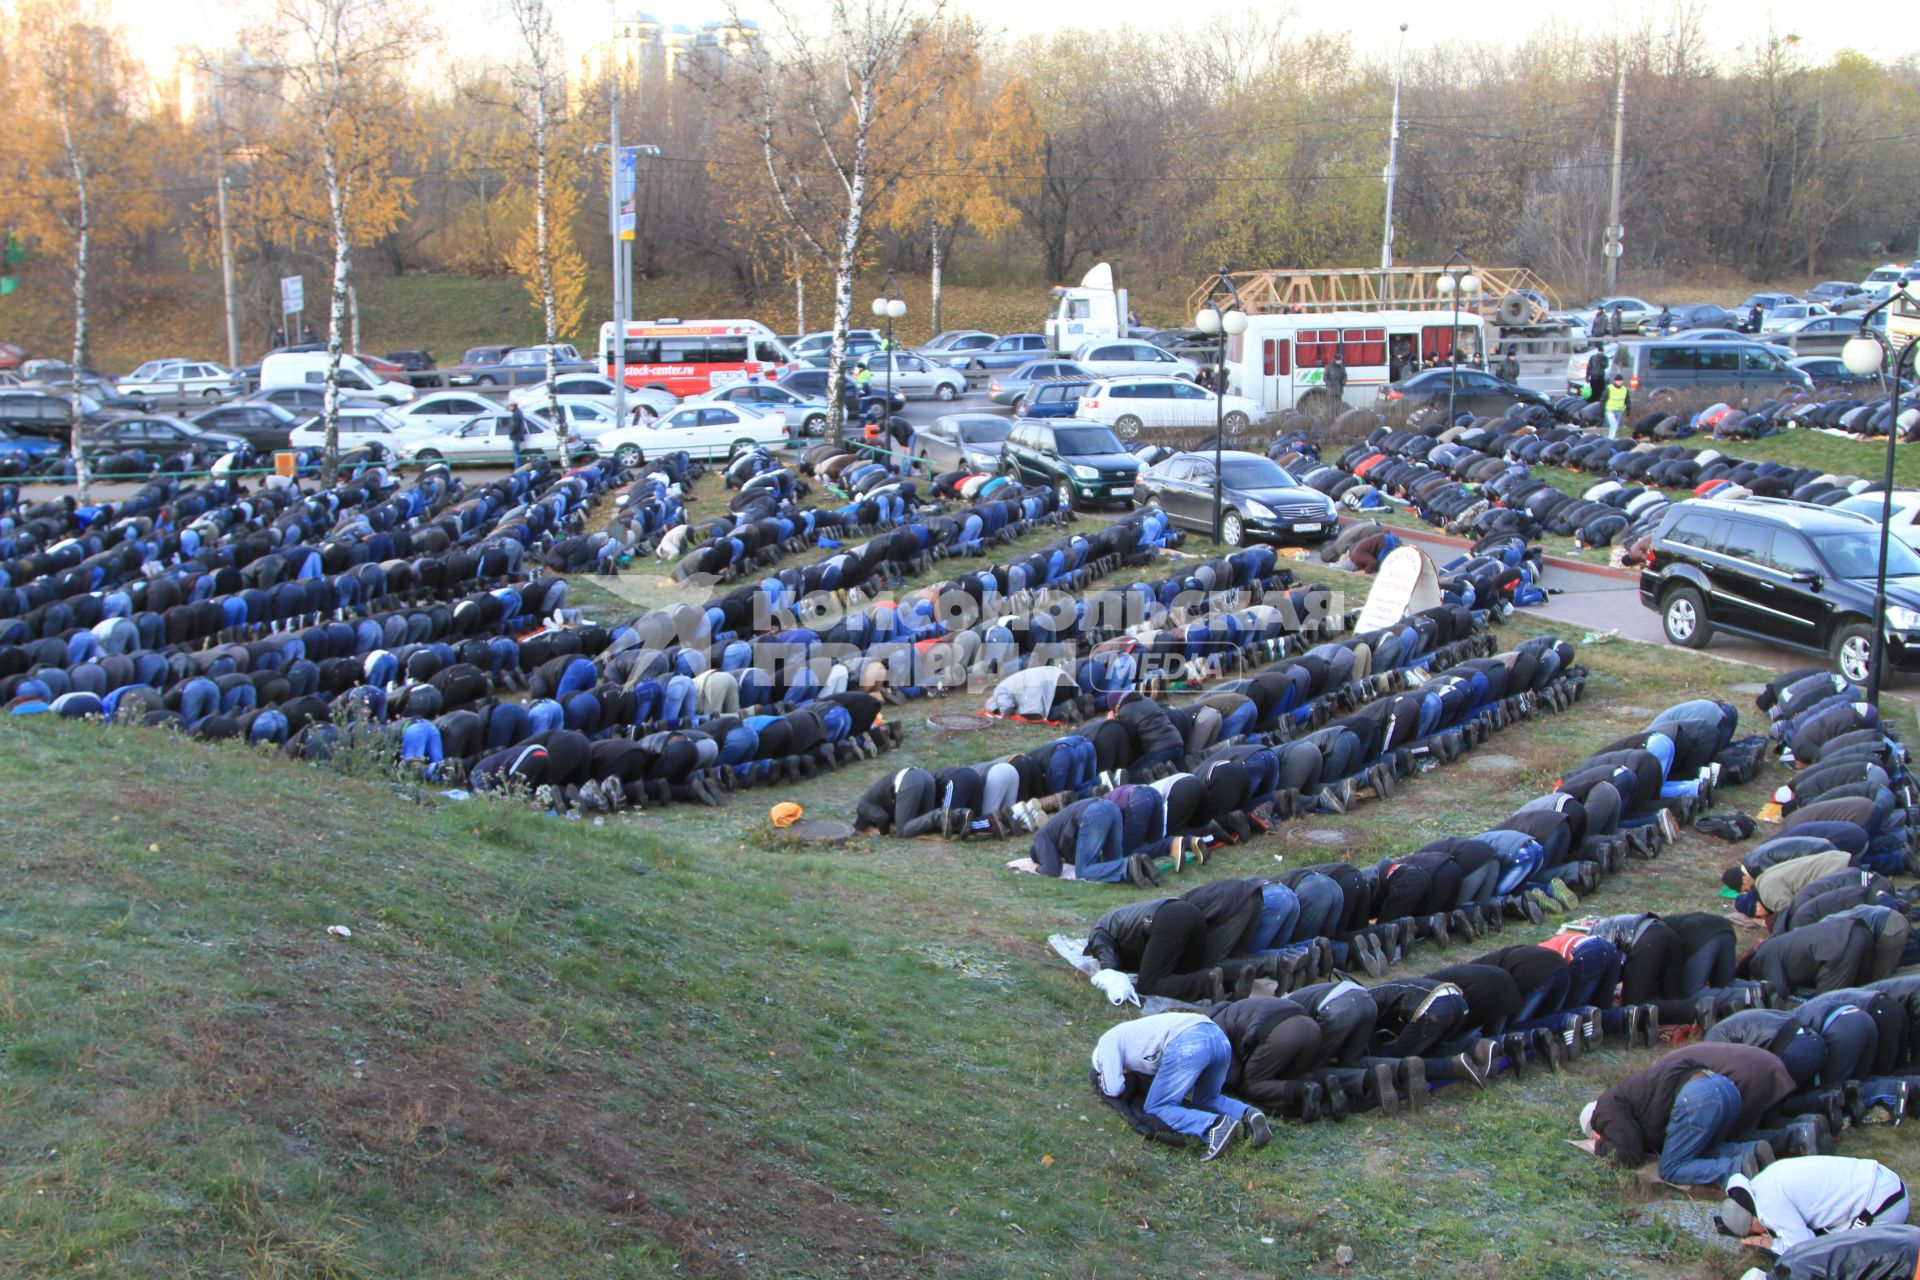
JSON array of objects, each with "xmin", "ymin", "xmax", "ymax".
[{"xmin": 1640, "ymin": 497, "xmax": 1920, "ymax": 683}]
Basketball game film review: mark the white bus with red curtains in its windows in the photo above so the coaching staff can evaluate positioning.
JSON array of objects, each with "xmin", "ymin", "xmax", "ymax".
[{"xmin": 1227, "ymin": 311, "xmax": 1486, "ymax": 413}]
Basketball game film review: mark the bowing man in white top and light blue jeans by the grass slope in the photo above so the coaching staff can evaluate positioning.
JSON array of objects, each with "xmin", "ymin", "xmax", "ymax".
[{"xmin": 1092, "ymin": 1013, "xmax": 1273, "ymax": 1159}]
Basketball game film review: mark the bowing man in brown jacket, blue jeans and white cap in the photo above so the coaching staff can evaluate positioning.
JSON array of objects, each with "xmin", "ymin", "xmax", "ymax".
[{"xmin": 1580, "ymin": 1044, "xmax": 1818, "ymax": 1186}]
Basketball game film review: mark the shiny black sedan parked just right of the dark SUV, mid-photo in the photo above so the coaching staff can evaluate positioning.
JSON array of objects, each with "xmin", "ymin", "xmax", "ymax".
[{"xmin": 1133, "ymin": 451, "xmax": 1340, "ymax": 547}]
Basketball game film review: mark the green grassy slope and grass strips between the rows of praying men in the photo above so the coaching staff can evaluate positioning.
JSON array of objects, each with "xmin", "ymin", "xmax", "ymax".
[{"xmin": 0, "ymin": 514, "xmax": 1920, "ymax": 1278}]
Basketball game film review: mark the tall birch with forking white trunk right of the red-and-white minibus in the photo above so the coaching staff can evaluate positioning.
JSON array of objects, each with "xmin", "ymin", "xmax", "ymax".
[{"xmin": 718, "ymin": 0, "xmax": 977, "ymax": 439}]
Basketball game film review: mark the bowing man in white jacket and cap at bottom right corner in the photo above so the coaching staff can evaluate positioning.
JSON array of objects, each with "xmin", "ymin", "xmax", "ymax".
[{"xmin": 1715, "ymin": 1155, "xmax": 1908, "ymax": 1274}]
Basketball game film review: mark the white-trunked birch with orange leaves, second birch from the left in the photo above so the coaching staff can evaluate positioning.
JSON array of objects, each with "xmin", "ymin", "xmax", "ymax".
[{"xmin": 276, "ymin": 0, "xmax": 424, "ymax": 486}]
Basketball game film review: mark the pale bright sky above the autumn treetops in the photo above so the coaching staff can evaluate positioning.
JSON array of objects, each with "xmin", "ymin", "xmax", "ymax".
[{"xmin": 108, "ymin": 0, "xmax": 1920, "ymax": 82}]
